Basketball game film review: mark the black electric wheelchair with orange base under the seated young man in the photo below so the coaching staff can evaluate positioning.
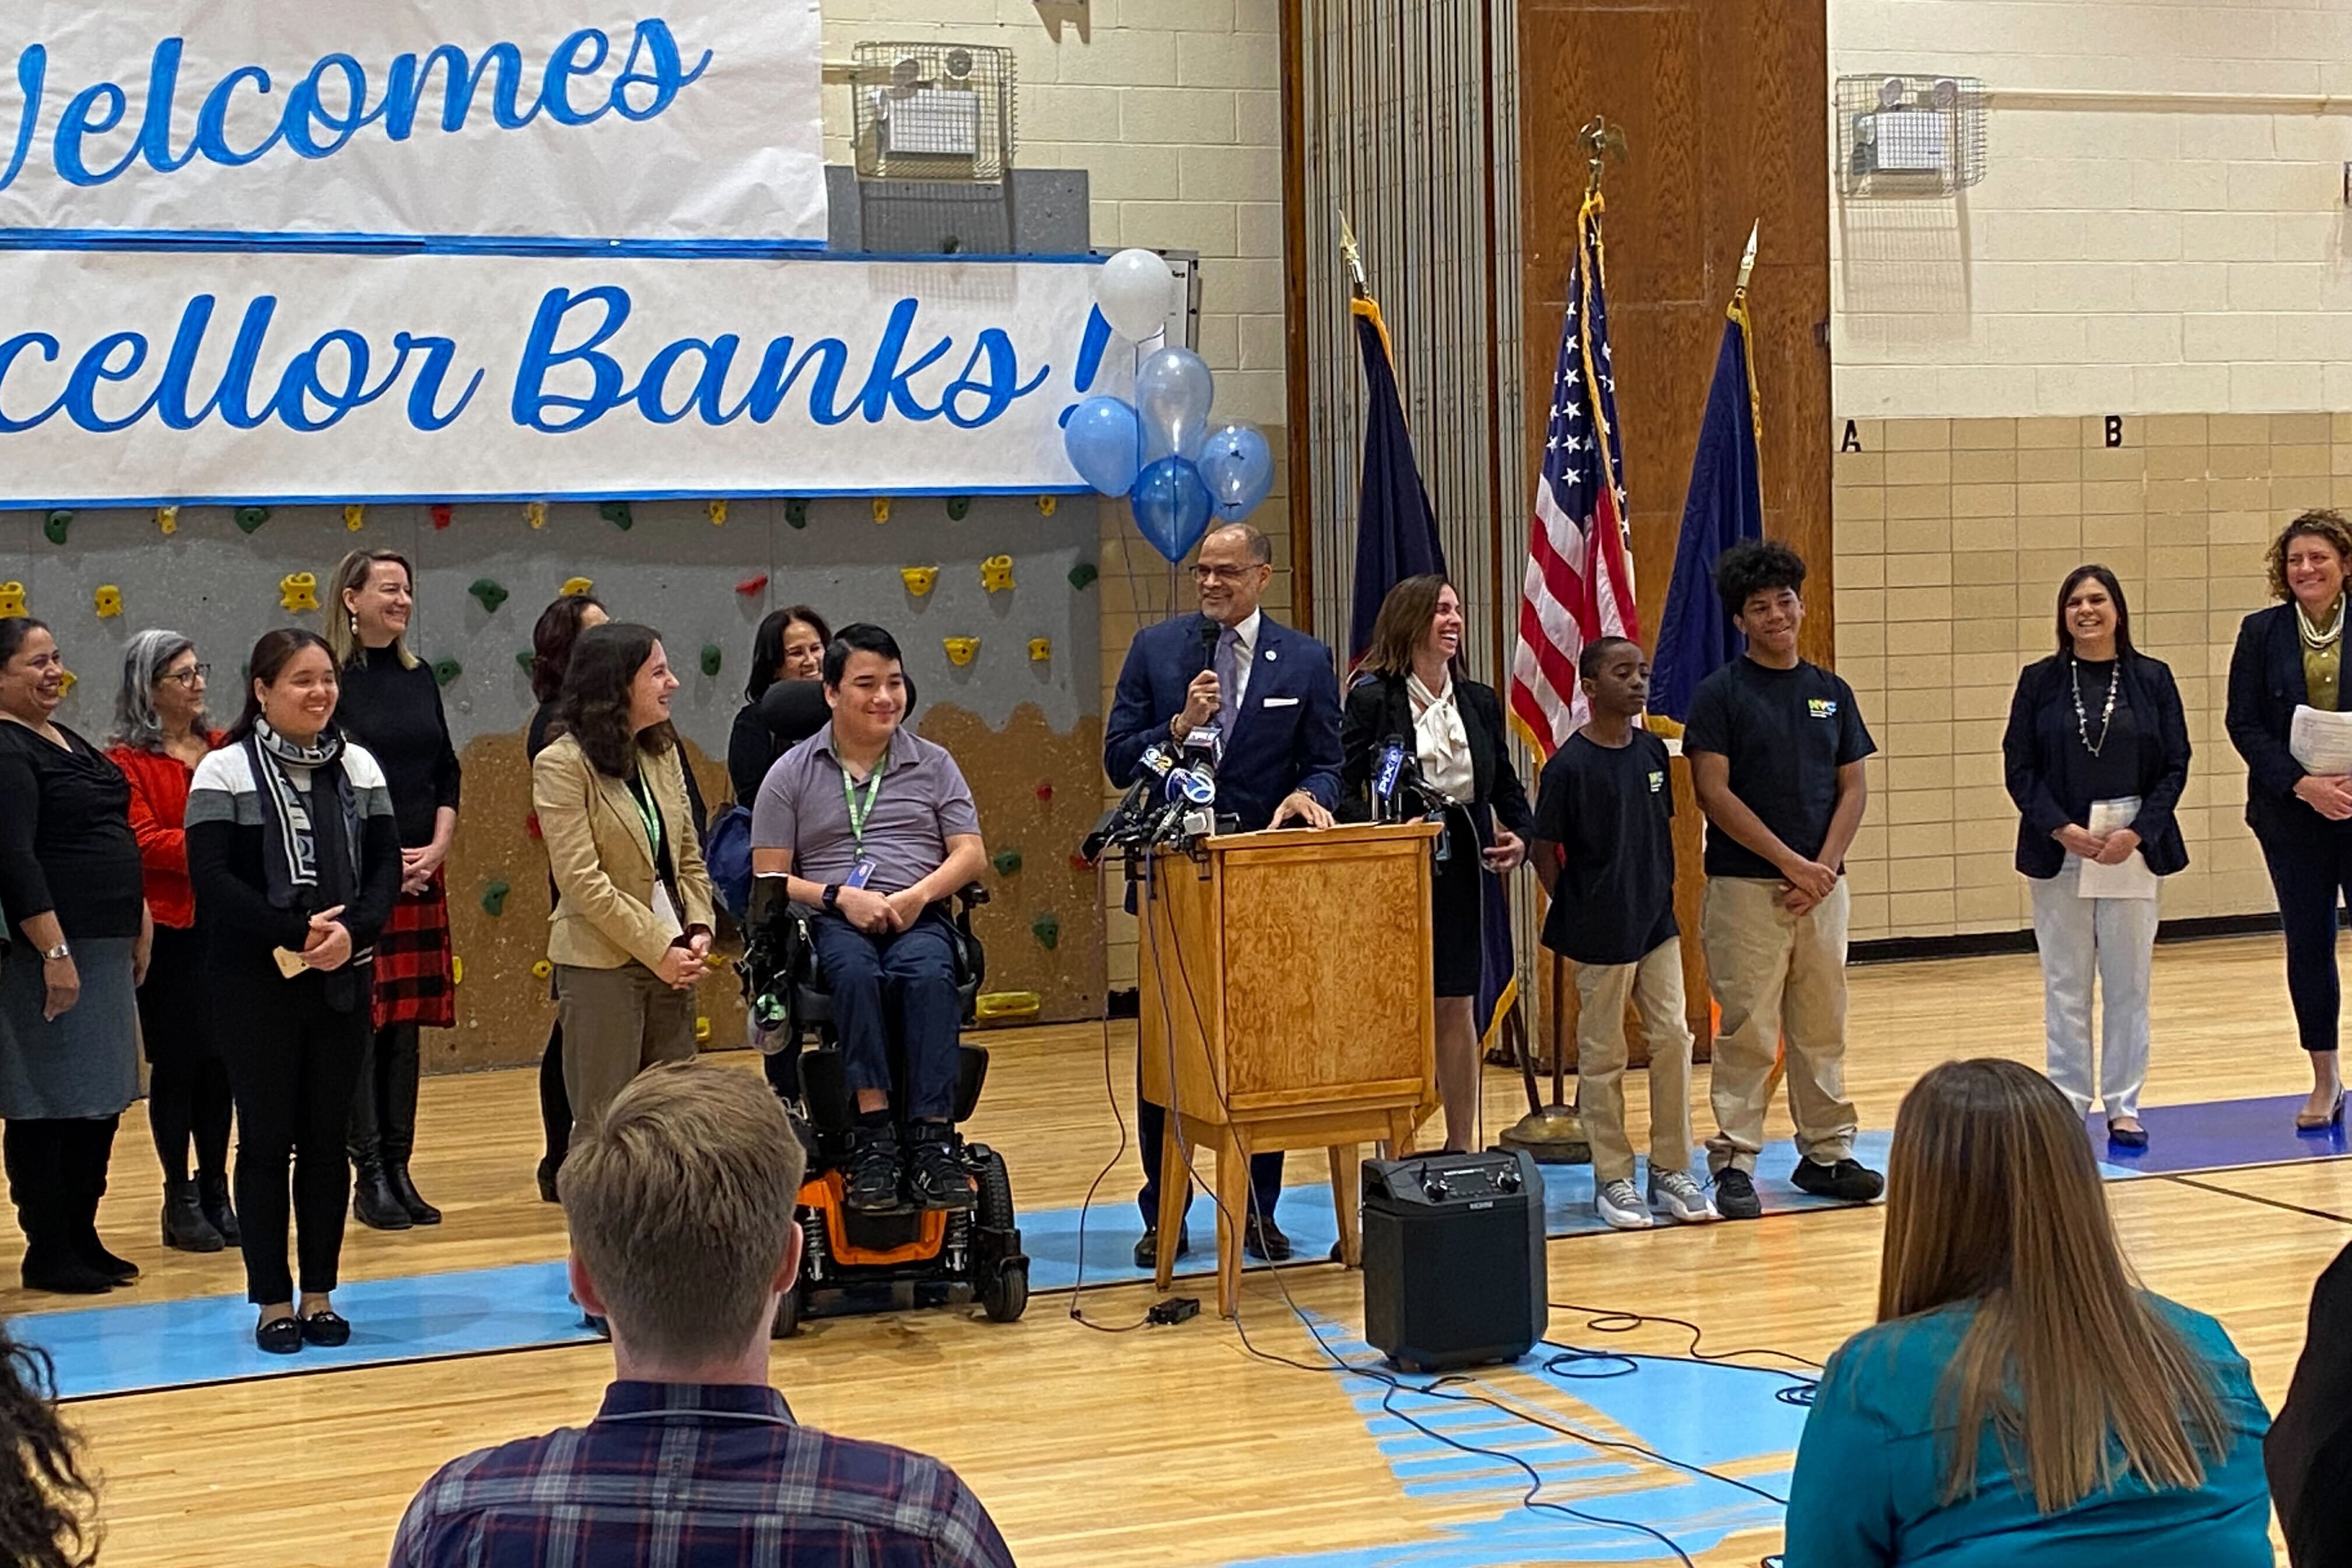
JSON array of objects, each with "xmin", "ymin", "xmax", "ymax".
[{"xmin": 738, "ymin": 877, "xmax": 1028, "ymax": 1340}]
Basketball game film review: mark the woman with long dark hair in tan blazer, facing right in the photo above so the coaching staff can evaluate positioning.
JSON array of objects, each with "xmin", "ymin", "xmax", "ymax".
[{"xmin": 531, "ymin": 621, "xmax": 713, "ymax": 1140}]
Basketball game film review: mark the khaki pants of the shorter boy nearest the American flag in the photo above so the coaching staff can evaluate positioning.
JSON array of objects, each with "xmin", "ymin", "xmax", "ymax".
[{"xmin": 1576, "ymin": 936, "xmax": 1691, "ymax": 1187}]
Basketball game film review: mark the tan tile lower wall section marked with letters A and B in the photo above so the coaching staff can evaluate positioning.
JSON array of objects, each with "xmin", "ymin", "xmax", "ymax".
[{"xmin": 1835, "ymin": 414, "xmax": 2352, "ymax": 940}]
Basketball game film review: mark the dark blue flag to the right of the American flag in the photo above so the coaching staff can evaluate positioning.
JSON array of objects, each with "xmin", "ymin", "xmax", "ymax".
[{"xmin": 1648, "ymin": 301, "xmax": 1764, "ymax": 724}]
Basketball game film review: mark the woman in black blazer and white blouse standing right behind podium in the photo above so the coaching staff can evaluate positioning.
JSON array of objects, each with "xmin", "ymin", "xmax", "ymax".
[{"xmin": 1338, "ymin": 573, "xmax": 1536, "ymax": 1150}]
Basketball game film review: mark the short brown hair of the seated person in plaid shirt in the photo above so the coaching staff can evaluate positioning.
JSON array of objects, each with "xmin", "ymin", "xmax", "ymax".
[{"xmin": 558, "ymin": 1060, "xmax": 807, "ymax": 1361}]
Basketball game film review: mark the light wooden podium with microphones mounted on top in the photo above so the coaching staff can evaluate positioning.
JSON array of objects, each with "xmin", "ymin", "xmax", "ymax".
[{"xmin": 1136, "ymin": 822, "xmax": 1437, "ymax": 1317}]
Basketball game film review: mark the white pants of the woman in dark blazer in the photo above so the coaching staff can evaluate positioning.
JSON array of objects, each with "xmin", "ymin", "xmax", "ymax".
[{"xmin": 2028, "ymin": 853, "xmax": 2157, "ymax": 1119}]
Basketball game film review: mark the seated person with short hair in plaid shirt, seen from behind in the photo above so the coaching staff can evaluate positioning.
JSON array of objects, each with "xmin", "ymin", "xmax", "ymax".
[{"xmin": 390, "ymin": 1063, "xmax": 1014, "ymax": 1568}]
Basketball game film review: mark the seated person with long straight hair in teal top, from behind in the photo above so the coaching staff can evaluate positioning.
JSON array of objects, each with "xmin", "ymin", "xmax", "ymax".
[{"xmin": 1787, "ymin": 1060, "xmax": 2272, "ymax": 1568}]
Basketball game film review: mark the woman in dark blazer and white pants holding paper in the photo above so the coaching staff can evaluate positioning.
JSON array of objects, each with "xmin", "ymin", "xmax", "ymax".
[{"xmin": 2001, "ymin": 566, "xmax": 2190, "ymax": 1150}]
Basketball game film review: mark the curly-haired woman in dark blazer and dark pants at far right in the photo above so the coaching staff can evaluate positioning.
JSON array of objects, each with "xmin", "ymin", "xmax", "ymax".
[{"xmin": 2227, "ymin": 510, "xmax": 2352, "ymax": 1130}]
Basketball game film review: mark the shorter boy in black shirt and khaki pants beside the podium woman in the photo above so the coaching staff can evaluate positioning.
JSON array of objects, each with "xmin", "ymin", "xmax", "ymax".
[{"xmin": 1534, "ymin": 637, "xmax": 1717, "ymax": 1230}]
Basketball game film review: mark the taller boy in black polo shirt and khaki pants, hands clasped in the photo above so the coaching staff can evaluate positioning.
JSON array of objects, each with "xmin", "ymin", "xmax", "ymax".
[{"xmin": 1682, "ymin": 538, "xmax": 1887, "ymax": 1220}]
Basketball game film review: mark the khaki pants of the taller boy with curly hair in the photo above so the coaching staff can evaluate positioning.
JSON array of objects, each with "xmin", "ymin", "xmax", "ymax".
[{"xmin": 1712, "ymin": 877, "xmax": 1856, "ymax": 1173}]
